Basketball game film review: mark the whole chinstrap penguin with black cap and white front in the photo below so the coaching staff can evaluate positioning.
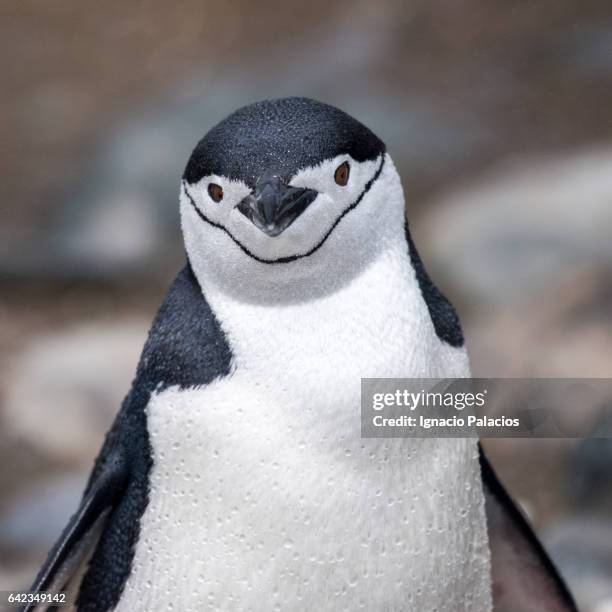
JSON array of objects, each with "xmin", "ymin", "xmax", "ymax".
[{"xmin": 26, "ymin": 98, "xmax": 575, "ymax": 612}]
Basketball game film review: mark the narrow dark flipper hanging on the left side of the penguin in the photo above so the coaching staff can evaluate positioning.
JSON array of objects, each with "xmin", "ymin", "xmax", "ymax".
[{"xmin": 22, "ymin": 444, "xmax": 128, "ymax": 612}]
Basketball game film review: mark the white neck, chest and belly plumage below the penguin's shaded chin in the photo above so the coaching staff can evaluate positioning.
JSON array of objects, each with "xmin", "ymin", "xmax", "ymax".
[{"xmin": 117, "ymin": 249, "xmax": 491, "ymax": 612}]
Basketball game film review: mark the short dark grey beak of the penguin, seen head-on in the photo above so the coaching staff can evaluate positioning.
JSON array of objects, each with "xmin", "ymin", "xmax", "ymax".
[{"xmin": 236, "ymin": 175, "xmax": 318, "ymax": 237}]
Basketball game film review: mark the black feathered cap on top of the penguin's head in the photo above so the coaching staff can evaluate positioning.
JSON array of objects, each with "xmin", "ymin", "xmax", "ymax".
[{"xmin": 183, "ymin": 98, "xmax": 385, "ymax": 188}]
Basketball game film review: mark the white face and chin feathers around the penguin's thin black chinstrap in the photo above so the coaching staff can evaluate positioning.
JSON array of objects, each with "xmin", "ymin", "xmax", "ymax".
[{"xmin": 181, "ymin": 155, "xmax": 404, "ymax": 303}]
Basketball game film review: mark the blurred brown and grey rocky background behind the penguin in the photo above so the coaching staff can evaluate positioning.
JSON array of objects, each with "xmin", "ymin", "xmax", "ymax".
[{"xmin": 0, "ymin": 0, "xmax": 612, "ymax": 612}]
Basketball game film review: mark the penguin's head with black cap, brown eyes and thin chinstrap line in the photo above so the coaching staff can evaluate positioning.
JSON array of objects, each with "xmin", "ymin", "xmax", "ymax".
[{"xmin": 181, "ymin": 98, "xmax": 403, "ymax": 300}]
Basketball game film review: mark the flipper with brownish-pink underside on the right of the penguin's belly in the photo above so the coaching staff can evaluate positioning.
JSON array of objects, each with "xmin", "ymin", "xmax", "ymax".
[{"xmin": 480, "ymin": 448, "xmax": 578, "ymax": 612}]
